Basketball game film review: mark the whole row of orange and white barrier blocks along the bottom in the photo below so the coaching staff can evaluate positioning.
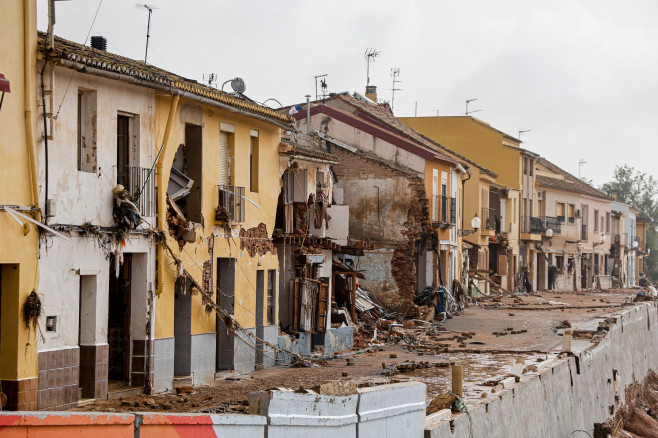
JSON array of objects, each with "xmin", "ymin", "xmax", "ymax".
[{"xmin": 0, "ymin": 382, "xmax": 425, "ymax": 438}]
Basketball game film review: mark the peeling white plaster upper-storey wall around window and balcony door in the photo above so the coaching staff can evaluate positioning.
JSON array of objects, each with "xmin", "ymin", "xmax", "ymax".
[{"xmin": 37, "ymin": 67, "xmax": 156, "ymax": 226}]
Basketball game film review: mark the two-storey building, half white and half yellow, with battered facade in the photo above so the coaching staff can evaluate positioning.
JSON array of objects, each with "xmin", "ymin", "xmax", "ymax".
[{"xmin": 1, "ymin": 28, "xmax": 292, "ymax": 410}]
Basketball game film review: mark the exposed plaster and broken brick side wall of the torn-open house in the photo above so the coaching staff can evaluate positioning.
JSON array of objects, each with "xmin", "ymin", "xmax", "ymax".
[{"xmin": 333, "ymin": 148, "xmax": 436, "ymax": 306}]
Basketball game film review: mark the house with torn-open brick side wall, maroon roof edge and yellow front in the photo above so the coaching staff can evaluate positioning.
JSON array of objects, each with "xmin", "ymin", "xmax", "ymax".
[{"xmin": 294, "ymin": 93, "xmax": 465, "ymax": 310}]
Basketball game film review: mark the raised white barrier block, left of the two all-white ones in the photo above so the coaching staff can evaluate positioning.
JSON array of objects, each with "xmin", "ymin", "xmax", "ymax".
[{"xmin": 256, "ymin": 391, "xmax": 359, "ymax": 438}]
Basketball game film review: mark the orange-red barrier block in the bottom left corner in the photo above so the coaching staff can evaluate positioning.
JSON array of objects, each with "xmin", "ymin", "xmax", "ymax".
[{"xmin": 0, "ymin": 412, "xmax": 135, "ymax": 438}]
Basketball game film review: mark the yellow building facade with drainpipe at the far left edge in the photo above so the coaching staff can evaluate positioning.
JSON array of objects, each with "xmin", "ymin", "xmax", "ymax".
[{"xmin": 0, "ymin": 0, "xmax": 40, "ymax": 410}]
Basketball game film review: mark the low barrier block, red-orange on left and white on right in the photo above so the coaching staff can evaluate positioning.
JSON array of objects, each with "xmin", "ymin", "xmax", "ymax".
[{"xmin": 136, "ymin": 413, "xmax": 267, "ymax": 438}]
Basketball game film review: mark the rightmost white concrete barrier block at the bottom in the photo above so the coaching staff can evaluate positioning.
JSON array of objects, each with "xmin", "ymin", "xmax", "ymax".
[{"xmin": 357, "ymin": 382, "xmax": 426, "ymax": 438}]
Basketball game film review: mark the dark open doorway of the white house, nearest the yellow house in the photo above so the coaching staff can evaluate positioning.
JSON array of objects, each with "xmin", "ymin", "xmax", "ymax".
[{"xmin": 107, "ymin": 254, "xmax": 132, "ymax": 384}]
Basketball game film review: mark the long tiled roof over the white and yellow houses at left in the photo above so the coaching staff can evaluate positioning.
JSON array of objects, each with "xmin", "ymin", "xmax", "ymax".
[{"xmin": 38, "ymin": 32, "xmax": 294, "ymax": 124}]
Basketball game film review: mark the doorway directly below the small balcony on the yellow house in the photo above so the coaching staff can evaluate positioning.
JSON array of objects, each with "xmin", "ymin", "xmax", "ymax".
[{"xmin": 215, "ymin": 257, "xmax": 236, "ymax": 371}]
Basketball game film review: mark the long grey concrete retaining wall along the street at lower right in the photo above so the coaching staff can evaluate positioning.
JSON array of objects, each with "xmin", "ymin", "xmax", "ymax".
[{"xmin": 425, "ymin": 303, "xmax": 658, "ymax": 438}]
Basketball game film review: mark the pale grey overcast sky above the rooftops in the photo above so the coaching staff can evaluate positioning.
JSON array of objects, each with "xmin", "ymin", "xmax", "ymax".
[{"xmin": 38, "ymin": 0, "xmax": 658, "ymax": 186}]
